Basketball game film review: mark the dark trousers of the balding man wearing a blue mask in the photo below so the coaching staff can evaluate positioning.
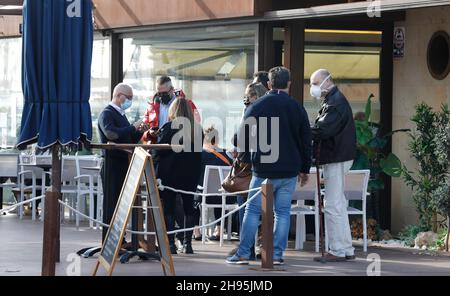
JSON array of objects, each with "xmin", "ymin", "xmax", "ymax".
[{"xmin": 101, "ymin": 153, "xmax": 128, "ymax": 242}]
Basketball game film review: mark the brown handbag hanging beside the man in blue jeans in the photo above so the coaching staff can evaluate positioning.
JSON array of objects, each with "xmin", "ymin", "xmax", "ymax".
[{"xmin": 222, "ymin": 159, "xmax": 252, "ymax": 197}]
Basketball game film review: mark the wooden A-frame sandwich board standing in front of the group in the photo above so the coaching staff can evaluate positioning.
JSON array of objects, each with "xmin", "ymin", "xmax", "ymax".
[{"xmin": 93, "ymin": 148, "xmax": 175, "ymax": 276}]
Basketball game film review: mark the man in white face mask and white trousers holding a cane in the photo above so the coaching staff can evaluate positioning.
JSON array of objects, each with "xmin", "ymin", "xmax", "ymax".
[{"xmin": 311, "ymin": 69, "xmax": 356, "ymax": 262}]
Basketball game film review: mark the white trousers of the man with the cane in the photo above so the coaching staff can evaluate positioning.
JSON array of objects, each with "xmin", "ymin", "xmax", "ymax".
[{"xmin": 323, "ymin": 161, "xmax": 355, "ymax": 257}]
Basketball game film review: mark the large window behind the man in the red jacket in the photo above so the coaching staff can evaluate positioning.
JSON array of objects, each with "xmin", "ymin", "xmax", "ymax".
[{"xmin": 124, "ymin": 25, "xmax": 256, "ymax": 147}]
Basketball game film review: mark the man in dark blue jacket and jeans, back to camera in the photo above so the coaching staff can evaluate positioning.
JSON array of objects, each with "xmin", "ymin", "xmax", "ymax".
[{"xmin": 227, "ymin": 67, "xmax": 312, "ymax": 265}]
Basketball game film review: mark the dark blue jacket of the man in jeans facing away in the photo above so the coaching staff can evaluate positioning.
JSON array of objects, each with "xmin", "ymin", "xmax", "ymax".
[{"xmin": 238, "ymin": 90, "xmax": 312, "ymax": 179}]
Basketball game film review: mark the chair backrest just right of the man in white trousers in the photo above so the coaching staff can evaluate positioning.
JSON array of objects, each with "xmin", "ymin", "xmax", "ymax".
[{"xmin": 344, "ymin": 170, "xmax": 370, "ymax": 200}]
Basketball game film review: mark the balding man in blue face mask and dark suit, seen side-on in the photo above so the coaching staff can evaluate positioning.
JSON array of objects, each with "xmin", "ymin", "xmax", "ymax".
[{"xmin": 98, "ymin": 83, "xmax": 149, "ymax": 240}]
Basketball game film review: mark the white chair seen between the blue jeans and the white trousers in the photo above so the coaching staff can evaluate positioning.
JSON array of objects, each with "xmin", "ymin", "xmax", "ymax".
[{"xmin": 291, "ymin": 169, "xmax": 320, "ymax": 252}]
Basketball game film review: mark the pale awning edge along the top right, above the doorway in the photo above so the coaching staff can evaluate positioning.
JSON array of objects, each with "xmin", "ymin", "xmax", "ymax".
[{"xmin": 264, "ymin": 0, "xmax": 450, "ymax": 21}]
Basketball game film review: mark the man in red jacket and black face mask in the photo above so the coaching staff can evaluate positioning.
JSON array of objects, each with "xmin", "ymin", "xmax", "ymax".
[{"xmin": 142, "ymin": 76, "xmax": 201, "ymax": 144}]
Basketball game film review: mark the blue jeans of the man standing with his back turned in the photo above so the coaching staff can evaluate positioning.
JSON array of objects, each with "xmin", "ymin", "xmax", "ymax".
[{"xmin": 237, "ymin": 176, "xmax": 297, "ymax": 260}]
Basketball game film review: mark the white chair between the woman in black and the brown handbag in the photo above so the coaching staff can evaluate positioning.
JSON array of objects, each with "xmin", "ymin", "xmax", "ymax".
[{"xmin": 201, "ymin": 165, "xmax": 238, "ymax": 246}]
